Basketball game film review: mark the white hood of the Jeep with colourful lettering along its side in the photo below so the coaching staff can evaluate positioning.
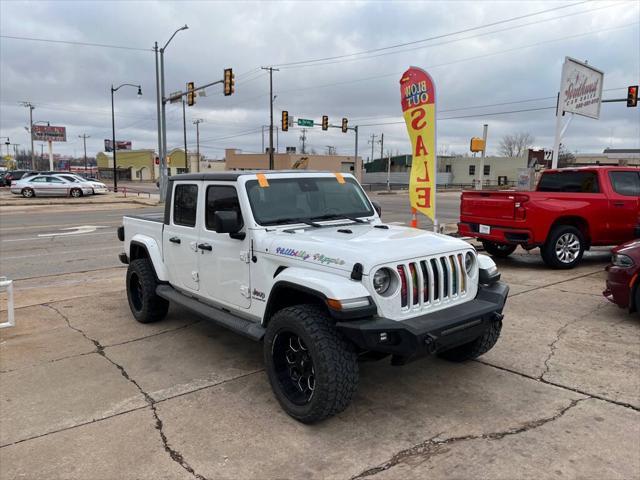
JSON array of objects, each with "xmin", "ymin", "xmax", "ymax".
[{"xmin": 256, "ymin": 224, "xmax": 471, "ymax": 274}]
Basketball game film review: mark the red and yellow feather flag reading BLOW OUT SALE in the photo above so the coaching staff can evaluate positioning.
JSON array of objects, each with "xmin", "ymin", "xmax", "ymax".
[{"xmin": 400, "ymin": 67, "xmax": 436, "ymax": 221}]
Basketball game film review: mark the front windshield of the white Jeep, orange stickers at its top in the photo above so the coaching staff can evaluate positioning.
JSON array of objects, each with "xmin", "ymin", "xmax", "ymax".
[{"xmin": 246, "ymin": 176, "xmax": 373, "ymax": 226}]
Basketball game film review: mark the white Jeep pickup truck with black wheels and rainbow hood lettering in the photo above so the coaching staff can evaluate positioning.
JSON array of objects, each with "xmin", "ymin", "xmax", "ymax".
[{"xmin": 118, "ymin": 170, "xmax": 509, "ymax": 423}]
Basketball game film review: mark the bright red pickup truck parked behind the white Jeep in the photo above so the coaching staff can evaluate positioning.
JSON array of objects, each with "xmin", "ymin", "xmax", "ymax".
[{"xmin": 458, "ymin": 167, "xmax": 640, "ymax": 268}]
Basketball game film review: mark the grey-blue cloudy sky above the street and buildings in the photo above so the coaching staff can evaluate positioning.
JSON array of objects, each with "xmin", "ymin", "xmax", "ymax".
[{"xmin": 0, "ymin": 0, "xmax": 640, "ymax": 159}]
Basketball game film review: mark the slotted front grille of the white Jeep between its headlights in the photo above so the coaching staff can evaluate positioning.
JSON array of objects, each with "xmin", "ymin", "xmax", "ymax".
[{"xmin": 397, "ymin": 253, "xmax": 468, "ymax": 310}]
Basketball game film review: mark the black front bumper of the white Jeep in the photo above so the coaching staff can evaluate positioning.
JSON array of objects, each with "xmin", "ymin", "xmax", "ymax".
[{"xmin": 336, "ymin": 282, "xmax": 509, "ymax": 363}]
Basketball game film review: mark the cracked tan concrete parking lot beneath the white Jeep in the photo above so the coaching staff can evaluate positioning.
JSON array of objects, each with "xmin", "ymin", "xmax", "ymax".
[{"xmin": 0, "ymin": 196, "xmax": 640, "ymax": 479}]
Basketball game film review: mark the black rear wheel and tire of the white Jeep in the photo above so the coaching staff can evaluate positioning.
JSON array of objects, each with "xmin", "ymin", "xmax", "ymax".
[{"xmin": 127, "ymin": 258, "xmax": 169, "ymax": 323}]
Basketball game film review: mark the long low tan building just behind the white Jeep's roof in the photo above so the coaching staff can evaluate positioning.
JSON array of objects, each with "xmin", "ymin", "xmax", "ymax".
[{"xmin": 225, "ymin": 148, "xmax": 362, "ymax": 180}]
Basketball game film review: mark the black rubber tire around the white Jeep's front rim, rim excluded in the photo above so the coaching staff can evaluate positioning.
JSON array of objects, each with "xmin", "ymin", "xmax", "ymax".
[{"xmin": 264, "ymin": 305, "xmax": 358, "ymax": 423}]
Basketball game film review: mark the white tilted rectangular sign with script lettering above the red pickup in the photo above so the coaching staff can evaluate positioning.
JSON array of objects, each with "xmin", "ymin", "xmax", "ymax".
[{"xmin": 560, "ymin": 57, "xmax": 604, "ymax": 119}]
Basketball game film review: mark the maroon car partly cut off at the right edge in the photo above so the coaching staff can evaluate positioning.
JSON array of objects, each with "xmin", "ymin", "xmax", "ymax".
[{"xmin": 602, "ymin": 238, "xmax": 640, "ymax": 313}]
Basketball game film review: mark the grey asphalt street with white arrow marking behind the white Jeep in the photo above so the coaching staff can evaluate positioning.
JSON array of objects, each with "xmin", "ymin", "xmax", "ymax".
[{"xmin": 0, "ymin": 192, "xmax": 460, "ymax": 280}]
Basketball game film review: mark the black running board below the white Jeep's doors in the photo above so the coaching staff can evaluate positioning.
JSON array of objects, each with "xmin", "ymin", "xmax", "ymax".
[{"xmin": 156, "ymin": 285, "xmax": 265, "ymax": 341}]
